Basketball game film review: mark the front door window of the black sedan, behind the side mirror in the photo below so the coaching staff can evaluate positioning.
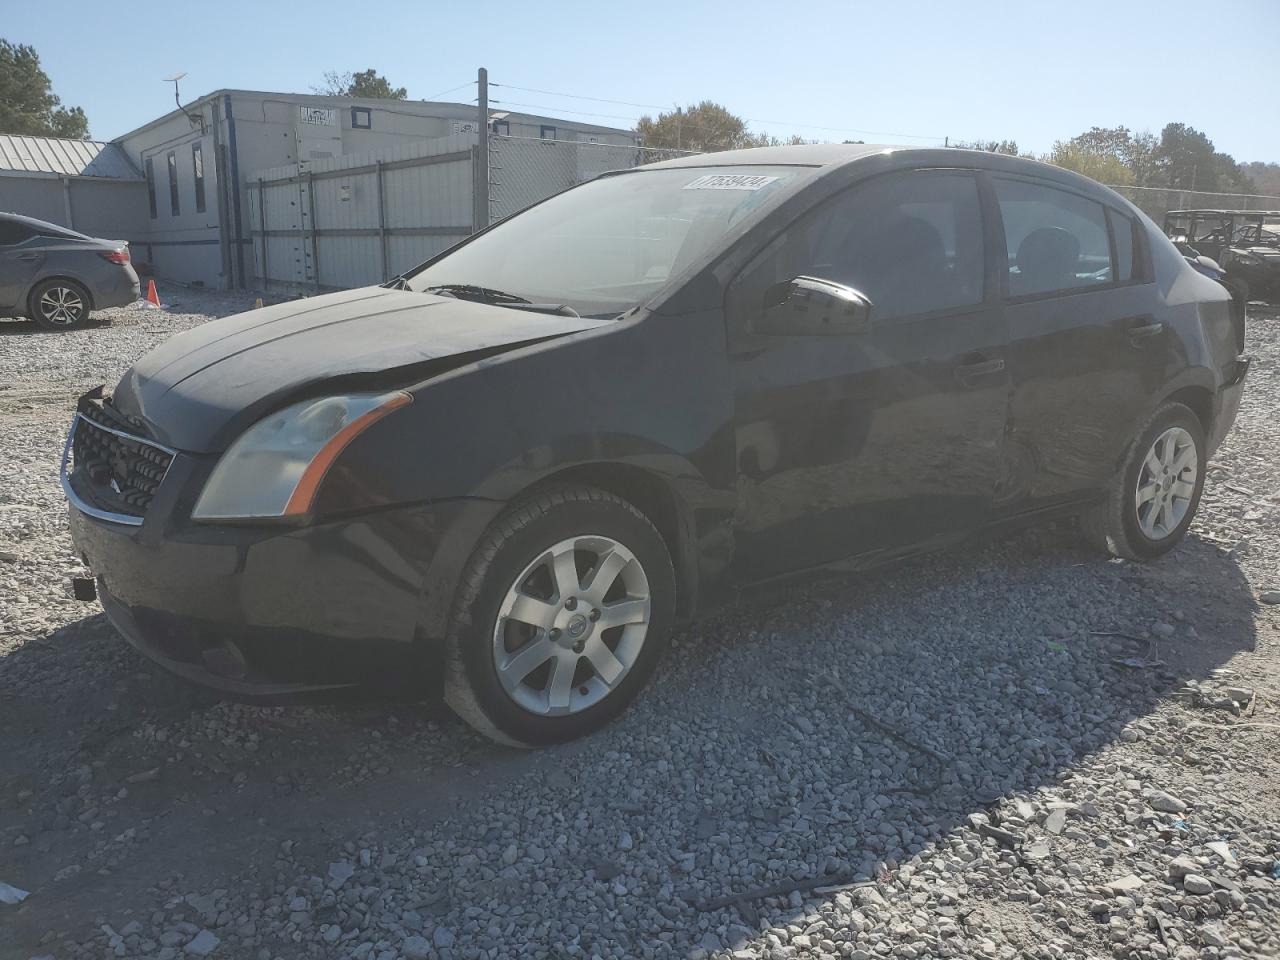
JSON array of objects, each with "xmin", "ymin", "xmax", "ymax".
[{"xmin": 742, "ymin": 172, "xmax": 983, "ymax": 321}]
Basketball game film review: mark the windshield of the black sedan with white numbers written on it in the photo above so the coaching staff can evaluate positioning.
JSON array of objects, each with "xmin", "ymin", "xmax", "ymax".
[{"xmin": 408, "ymin": 166, "xmax": 809, "ymax": 316}]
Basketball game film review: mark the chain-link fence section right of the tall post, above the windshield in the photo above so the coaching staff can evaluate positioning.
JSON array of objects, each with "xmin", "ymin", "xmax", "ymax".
[{"xmin": 489, "ymin": 136, "xmax": 695, "ymax": 223}]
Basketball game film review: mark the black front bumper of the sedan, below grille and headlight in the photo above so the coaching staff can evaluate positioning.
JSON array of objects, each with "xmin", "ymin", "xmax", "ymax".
[{"xmin": 70, "ymin": 502, "xmax": 467, "ymax": 703}]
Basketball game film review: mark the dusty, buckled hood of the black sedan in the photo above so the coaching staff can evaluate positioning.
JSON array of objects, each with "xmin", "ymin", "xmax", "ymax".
[{"xmin": 113, "ymin": 287, "xmax": 609, "ymax": 453}]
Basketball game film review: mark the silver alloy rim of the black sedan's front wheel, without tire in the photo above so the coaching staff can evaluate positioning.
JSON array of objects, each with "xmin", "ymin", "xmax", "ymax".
[{"xmin": 493, "ymin": 536, "xmax": 650, "ymax": 717}]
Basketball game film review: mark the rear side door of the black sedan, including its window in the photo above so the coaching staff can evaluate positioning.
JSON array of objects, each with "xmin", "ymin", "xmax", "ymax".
[{"xmin": 991, "ymin": 175, "xmax": 1178, "ymax": 513}]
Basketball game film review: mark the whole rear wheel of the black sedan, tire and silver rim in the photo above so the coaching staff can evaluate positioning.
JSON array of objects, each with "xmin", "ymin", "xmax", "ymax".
[{"xmin": 1080, "ymin": 403, "xmax": 1206, "ymax": 561}]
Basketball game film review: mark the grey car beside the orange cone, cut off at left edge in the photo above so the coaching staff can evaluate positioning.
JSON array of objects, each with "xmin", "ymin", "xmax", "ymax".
[{"xmin": 0, "ymin": 212, "xmax": 138, "ymax": 330}]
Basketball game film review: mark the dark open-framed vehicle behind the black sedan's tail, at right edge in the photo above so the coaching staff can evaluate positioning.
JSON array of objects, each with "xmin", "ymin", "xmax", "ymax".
[{"xmin": 1165, "ymin": 210, "xmax": 1280, "ymax": 303}]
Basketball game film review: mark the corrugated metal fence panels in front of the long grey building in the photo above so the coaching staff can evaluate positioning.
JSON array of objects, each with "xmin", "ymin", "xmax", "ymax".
[{"xmin": 247, "ymin": 134, "xmax": 476, "ymax": 289}]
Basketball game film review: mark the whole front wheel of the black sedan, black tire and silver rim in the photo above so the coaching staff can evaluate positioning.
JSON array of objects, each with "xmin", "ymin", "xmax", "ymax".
[{"xmin": 444, "ymin": 485, "xmax": 676, "ymax": 746}]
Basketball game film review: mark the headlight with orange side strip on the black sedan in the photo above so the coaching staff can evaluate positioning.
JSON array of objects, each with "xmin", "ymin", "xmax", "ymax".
[{"xmin": 192, "ymin": 390, "xmax": 413, "ymax": 520}]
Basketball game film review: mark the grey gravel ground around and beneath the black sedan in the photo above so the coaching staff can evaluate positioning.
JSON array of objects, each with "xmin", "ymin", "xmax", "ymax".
[{"xmin": 0, "ymin": 291, "xmax": 1280, "ymax": 960}]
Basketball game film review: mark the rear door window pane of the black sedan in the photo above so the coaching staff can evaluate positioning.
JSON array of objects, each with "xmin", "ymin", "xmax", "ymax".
[{"xmin": 995, "ymin": 178, "xmax": 1111, "ymax": 297}]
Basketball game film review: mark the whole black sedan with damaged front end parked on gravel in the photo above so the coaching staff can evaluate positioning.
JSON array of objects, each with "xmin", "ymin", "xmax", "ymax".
[{"xmin": 63, "ymin": 146, "xmax": 1248, "ymax": 745}]
